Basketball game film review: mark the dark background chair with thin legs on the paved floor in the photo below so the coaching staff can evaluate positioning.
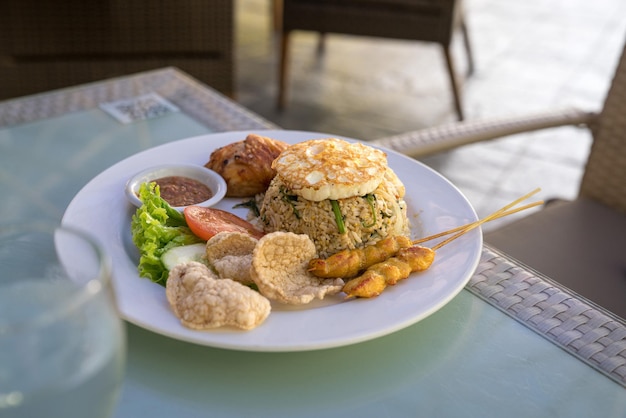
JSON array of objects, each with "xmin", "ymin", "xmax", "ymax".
[{"xmin": 274, "ymin": 0, "xmax": 474, "ymax": 120}]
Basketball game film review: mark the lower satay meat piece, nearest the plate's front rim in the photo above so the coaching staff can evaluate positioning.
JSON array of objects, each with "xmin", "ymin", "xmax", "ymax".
[{"xmin": 343, "ymin": 245, "xmax": 435, "ymax": 298}]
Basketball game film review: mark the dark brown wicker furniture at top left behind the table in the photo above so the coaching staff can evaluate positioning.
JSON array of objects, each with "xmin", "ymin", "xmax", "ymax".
[{"xmin": 0, "ymin": 0, "xmax": 235, "ymax": 99}]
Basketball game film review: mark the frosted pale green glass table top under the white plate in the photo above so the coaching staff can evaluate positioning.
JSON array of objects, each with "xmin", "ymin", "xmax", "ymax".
[{"xmin": 0, "ymin": 69, "xmax": 626, "ymax": 418}]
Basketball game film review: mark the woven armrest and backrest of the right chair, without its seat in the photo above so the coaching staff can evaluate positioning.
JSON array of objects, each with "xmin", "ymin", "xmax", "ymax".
[{"xmin": 371, "ymin": 40, "xmax": 626, "ymax": 213}]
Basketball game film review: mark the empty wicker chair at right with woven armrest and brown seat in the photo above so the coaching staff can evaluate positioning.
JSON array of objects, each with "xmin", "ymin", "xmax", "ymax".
[{"xmin": 374, "ymin": 40, "xmax": 626, "ymax": 318}]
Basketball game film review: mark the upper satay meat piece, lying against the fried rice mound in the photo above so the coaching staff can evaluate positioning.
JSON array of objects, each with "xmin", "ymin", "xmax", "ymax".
[{"xmin": 309, "ymin": 235, "xmax": 413, "ymax": 279}]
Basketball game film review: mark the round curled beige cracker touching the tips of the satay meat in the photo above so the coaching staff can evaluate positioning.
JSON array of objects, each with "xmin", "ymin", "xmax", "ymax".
[{"xmin": 251, "ymin": 232, "xmax": 343, "ymax": 305}]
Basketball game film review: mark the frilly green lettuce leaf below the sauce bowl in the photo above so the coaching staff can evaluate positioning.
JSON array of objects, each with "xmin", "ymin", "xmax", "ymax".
[{"xmin": 130, "ymin": 183, "xmax": 202, "ymax": 286}]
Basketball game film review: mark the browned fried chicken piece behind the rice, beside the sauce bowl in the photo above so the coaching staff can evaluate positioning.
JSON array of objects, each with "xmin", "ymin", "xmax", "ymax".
[{"xmin": 205, "ymin": 134, "xmax": 289, "ymax": 197}]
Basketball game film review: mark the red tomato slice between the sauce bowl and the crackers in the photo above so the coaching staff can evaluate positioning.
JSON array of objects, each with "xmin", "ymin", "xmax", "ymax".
[{"xmin": 183, "ymin": 206, "xmax": 264, "ymax": 241}]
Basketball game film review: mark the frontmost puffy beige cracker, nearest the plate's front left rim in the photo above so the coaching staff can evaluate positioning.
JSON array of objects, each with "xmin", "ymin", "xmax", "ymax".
[{"xmin": 165, "ymin": 261, "xmax": 271, "ymax": 330}]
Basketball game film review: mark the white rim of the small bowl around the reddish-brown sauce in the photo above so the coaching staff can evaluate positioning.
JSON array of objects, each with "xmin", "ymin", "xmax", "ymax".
[{"xmin": 125, "ymin": 164, "xmax": 226, "ymax": 211}]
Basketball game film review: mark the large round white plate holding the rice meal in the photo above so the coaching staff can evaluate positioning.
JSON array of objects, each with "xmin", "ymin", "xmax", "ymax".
[{"xmin": 63, "ymin": 130, "xmax": 482, "ymax": 351}]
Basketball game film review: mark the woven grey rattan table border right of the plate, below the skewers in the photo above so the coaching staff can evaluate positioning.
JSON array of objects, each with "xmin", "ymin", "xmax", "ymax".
[{"xmin": 466, "ymin": 246, "xmax": 626, "ymax": 387}]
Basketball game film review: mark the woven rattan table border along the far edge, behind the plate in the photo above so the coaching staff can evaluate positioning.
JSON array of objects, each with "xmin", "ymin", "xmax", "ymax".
[{"xmin": 0, "ymin": 68, "xmax": 275, "ymax": 132}]
